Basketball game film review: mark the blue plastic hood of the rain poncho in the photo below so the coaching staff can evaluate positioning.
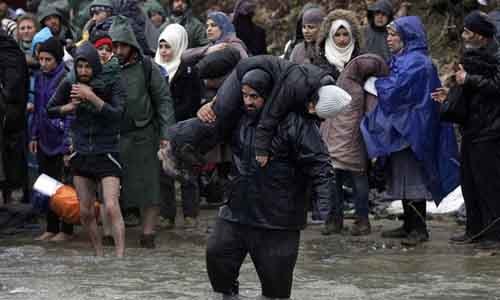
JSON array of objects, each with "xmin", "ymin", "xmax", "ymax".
[{"xmin": 389, "ymin": 16, "xmax": 428, "ymax": 53}]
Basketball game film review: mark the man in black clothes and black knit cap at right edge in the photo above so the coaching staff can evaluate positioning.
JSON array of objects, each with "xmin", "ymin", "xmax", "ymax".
[{"xmin": 432, "ymin": 11, "xmax": 500, "ymax": 249}]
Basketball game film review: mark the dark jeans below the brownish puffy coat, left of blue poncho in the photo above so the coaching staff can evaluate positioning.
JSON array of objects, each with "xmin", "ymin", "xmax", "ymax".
[{"xmin": 333, "ymin": 169, "xmax": 369, "ymax": 218}]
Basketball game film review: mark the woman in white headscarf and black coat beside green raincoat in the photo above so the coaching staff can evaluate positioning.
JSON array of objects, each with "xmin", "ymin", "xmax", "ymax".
[{"xmin": 155, "ymin": 24, "xmax": 201, "ymax": 229}]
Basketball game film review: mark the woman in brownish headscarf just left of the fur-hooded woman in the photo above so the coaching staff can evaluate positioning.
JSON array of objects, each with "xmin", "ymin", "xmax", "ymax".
[{"xmin": 290, "ymin": 7, "xmax": 325, "ymax": 64}]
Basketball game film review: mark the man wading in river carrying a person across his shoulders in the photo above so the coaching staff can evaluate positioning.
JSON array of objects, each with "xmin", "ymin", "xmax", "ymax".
[{"xmin": 206, "ymin": 69, "xmax": 333, "ymax": 299}]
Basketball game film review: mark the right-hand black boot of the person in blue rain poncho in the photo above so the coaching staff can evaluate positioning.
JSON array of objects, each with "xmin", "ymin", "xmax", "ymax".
[{"xmin": 401, "ymin": 200, "xmax": 429, "ymax": 247}]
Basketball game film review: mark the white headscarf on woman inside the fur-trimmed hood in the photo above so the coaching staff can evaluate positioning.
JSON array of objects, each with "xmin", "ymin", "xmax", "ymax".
[{"xmin": 325, "ymin": 19, "xmax": 355, "ymax": 72}]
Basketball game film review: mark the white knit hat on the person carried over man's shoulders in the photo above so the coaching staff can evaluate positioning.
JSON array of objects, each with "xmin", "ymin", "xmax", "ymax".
[{"xmin": 316, "ymin": 85, "xmax": 352, "ymax": 119}]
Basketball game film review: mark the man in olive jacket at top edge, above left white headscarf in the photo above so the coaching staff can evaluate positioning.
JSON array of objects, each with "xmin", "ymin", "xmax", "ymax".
[{"xmin": 162, "ymin": 0, "xmax": 208, "ymax": 48}]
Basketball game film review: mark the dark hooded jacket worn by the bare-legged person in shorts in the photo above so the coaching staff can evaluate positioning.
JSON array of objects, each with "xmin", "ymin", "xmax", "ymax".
[{"xmin": 47, "ymin": 42, "xmax": 126, "ymax": 154}]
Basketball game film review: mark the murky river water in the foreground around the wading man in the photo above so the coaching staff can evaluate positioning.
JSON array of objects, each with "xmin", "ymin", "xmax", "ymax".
[{"xmin": 0, "ymin": 220, "xmax": 500, "ymax": 300}]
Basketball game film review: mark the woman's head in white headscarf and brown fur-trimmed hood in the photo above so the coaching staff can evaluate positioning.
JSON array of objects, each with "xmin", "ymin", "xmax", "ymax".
[{"xmin": 312, "ymin": 9, "xmax": 362, "ymax": 77}]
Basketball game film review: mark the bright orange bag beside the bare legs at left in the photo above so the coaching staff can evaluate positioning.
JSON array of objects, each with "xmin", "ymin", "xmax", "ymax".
[{"xmin": 50, "ymin": 185, "xmax": 99, "ymax": 224}]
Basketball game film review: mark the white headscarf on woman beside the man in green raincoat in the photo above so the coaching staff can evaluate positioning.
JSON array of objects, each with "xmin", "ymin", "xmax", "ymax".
[{"xmin": 155, "ymin": 24, "xmax": 188, "ymax": 82}]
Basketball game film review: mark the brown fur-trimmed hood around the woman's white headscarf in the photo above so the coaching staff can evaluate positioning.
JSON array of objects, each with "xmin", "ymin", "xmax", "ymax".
[{"xmin": 317, "ymin": 9, "xmax": 364, "ymax": 49}]
